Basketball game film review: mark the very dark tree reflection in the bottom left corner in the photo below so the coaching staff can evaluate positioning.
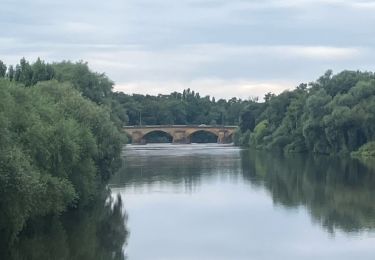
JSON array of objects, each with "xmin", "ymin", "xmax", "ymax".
[{"xmin": 0, "ymin": 189, "xmax": 128, "ymax": 260}]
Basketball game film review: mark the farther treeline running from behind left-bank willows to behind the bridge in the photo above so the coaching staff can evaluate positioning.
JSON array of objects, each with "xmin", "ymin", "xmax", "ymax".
[{"xmin": 0, "ymin": 58, "xmax": 249, "ymax": 126}]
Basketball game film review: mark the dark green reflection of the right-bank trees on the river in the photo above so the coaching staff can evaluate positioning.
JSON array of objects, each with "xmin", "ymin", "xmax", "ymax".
[{"xmin": 242, "ymin": 151, "xmax": 375, "ymax": 232}]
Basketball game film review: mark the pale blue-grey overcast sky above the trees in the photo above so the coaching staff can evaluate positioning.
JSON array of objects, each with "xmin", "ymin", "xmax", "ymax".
[{"xmin": 0, "ymin": 0, "xmax": 375, "ymax": 98}]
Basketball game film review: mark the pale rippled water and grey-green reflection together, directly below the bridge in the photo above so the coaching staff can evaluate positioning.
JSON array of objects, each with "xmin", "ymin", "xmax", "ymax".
[{"xmin": 110, "ymin": 144, "xmax": 241, "ymax": 192}]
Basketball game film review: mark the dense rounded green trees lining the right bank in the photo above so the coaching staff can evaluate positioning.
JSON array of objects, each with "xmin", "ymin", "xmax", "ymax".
[{"xmin": 235, "ymin": 71, "xmax": 375, "ymax": 156}]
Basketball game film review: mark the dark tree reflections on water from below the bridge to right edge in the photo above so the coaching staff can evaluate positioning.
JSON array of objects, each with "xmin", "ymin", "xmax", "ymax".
[{"xmin": 111, "ymin": 145, "xmax": 375, "ymax": 233}]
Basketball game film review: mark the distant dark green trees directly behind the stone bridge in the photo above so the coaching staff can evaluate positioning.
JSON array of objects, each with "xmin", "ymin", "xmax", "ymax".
[{"xmin": 114, "ymin": 89, "xmax": 248, "ymax": 125}]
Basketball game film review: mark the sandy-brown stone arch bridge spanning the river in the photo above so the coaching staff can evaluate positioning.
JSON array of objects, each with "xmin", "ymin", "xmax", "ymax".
[{"xmin": 124, "ymin": 125, "xmax": 237, "ymax": 144}]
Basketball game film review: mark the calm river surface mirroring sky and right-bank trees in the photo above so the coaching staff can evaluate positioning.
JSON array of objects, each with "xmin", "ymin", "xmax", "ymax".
[{"xmin": 110, "ymin": 144, "xmax": 375, "ymax": 260}]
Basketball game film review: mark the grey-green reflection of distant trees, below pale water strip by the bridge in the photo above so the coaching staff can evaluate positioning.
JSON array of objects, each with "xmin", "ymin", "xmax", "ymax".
[{"xmin": 111, "ymin": 153, "xmax": 240, "ymax": 191}]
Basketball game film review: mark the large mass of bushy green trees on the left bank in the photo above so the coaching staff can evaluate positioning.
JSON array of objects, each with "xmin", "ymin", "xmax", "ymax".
[{"xmin": 0, "ymin": 59, "xmax": 125, "ymax": 243}]
